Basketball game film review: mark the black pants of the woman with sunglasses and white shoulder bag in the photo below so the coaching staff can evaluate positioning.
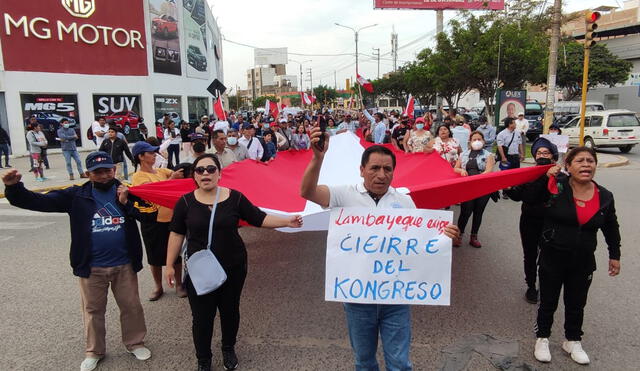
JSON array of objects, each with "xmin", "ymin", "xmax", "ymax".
[{"xmin": 186, "ymin": 264, "xmax": 247, "ymax": 360}]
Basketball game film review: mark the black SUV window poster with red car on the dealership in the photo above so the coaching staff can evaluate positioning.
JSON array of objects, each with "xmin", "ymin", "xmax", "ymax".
[{"xmin": 93, "ymin": 94, "xmax": 141, "ymax": 139}]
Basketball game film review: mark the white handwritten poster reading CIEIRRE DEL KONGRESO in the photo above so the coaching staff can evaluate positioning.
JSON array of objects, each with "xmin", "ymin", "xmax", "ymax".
[{"xmin": 325, "ymin": 207, "xmax": 453, "ymax": 305}]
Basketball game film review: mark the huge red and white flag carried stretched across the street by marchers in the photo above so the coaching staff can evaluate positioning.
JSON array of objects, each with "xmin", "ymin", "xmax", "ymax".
[{"xmin": 130, "ymin": 132, "xmax": 549, "ymax": 232}]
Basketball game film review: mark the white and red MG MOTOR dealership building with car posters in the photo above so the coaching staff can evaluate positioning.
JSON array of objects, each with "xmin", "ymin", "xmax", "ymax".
[{"xmin": 0, "ymin": 0, "xmax": 224, "ymax": 155}]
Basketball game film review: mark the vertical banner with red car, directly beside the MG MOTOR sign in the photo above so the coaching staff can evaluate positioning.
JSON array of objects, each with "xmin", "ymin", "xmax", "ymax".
[{"xmin": 149, "ymin": 0, "xmax": 182, "ymax": 75}]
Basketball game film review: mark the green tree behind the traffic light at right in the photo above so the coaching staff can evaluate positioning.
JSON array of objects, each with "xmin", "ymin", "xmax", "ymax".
[{"xmin": 557, "ymin": 40, "xmax": 633, "ymax": 100}]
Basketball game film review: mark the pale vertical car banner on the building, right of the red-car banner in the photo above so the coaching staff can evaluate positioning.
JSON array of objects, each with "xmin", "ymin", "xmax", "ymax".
[{"xmin": 182, "ymin": 0, "xmax": 211, "ymax": 79}]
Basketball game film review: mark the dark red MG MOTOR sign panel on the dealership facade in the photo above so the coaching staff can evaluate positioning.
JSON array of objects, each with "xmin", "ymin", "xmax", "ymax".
[{"xmin": 0, "ymin": 0, "xmax": 148, "ymax": 76}]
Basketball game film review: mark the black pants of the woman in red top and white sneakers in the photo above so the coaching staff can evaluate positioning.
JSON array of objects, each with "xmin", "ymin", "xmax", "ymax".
[{"xmin": 536, "ymin": 256, "xmax": 593, "ymax": 341}]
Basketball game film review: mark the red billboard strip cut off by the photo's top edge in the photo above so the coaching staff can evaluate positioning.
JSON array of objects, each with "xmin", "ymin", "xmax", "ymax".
[{"xmin": 374, "ymin": 0, "xmax": 504, "ymax": 10}]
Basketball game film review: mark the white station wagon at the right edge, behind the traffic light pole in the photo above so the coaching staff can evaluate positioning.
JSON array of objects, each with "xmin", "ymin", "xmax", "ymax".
[{"xmin": 562, "ymin": 109, "xmax": 640, "ymax": 153}]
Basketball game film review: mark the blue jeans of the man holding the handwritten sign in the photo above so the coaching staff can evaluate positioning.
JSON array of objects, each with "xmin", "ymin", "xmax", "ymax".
[{"xmin": 344, "ymin": 303, "xmax": 412, "ymax": 371}]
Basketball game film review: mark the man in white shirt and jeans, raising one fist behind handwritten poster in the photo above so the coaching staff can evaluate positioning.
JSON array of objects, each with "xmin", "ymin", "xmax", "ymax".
[{"xmin": 300, "ymin": 127, "xmax": 460, "ymax": 370}]
